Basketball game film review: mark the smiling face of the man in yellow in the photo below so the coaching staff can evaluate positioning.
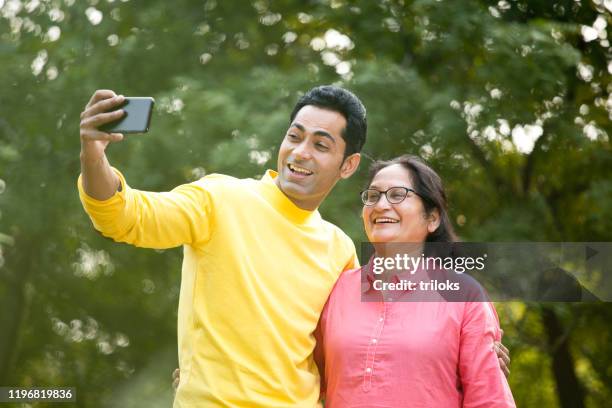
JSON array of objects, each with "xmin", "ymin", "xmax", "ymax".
[{"xmin": 276, "ymin": 105, "xmax": 359, "ymax": 210}]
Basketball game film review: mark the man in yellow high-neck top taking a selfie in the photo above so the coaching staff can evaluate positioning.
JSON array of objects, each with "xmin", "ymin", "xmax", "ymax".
[{"xmin": 78, "ymin": 86, "xmax": 506, "ymax": 407}]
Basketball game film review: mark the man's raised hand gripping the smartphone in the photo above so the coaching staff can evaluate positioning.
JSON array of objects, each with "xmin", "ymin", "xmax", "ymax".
[{"xmin": 80, "ymin": 89, "xmax": 125, "ymax": 163}]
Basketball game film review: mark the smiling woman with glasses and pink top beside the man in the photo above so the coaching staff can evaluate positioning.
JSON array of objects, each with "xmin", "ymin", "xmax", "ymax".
[{"xmin": 315, "ymin": 155, "xmax": 515, "ymax": 408}]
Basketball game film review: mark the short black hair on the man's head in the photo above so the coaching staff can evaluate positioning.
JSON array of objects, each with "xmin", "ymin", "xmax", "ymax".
[{"xmin": 289, "ymin": 85, "xmax": 368, "ymax": 158}]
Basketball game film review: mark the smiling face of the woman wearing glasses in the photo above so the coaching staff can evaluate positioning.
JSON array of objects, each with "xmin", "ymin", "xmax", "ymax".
[{"xmin": 362, "ymin": 164, "xmax": 439, "ymax": 243}]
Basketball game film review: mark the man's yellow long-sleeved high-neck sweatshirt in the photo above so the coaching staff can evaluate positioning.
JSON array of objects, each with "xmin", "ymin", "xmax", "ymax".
[{"xmin": 78, "ymin": 170, "xmax": 357, "ymax": 408}]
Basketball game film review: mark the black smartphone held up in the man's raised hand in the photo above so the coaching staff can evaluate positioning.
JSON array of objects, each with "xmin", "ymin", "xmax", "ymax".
[{"xmin": 100, "ymin": 96, "xmax": 155, "ymax": 133}]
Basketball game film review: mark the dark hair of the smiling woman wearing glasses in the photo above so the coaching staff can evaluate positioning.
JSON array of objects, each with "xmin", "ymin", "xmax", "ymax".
[{"xmin": 367, "ymin": 154, "xmax": 457, "ymax": 243}]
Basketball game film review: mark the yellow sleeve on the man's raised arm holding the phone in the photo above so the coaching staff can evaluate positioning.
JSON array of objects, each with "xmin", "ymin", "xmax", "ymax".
[{"xmin": 77, "ymin": 168, "xmax": 212, "ymax": 249}]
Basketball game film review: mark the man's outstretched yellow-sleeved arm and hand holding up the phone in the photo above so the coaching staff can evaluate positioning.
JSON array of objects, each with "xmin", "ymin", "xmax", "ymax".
[{"xmin": 78, "ymin": 90, "xmax": 212, "ymax": 249}]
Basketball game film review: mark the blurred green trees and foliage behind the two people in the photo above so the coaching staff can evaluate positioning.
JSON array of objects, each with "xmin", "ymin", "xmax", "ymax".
[{"xmin": 0, "ymin": 0, "xmax": 612, "ymax": 408}]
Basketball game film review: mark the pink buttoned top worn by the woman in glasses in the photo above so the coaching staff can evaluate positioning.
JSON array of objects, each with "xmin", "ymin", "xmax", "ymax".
[{"xmin": 315, "ymin": 269, "xmax": 515, "ymax": 408}]
